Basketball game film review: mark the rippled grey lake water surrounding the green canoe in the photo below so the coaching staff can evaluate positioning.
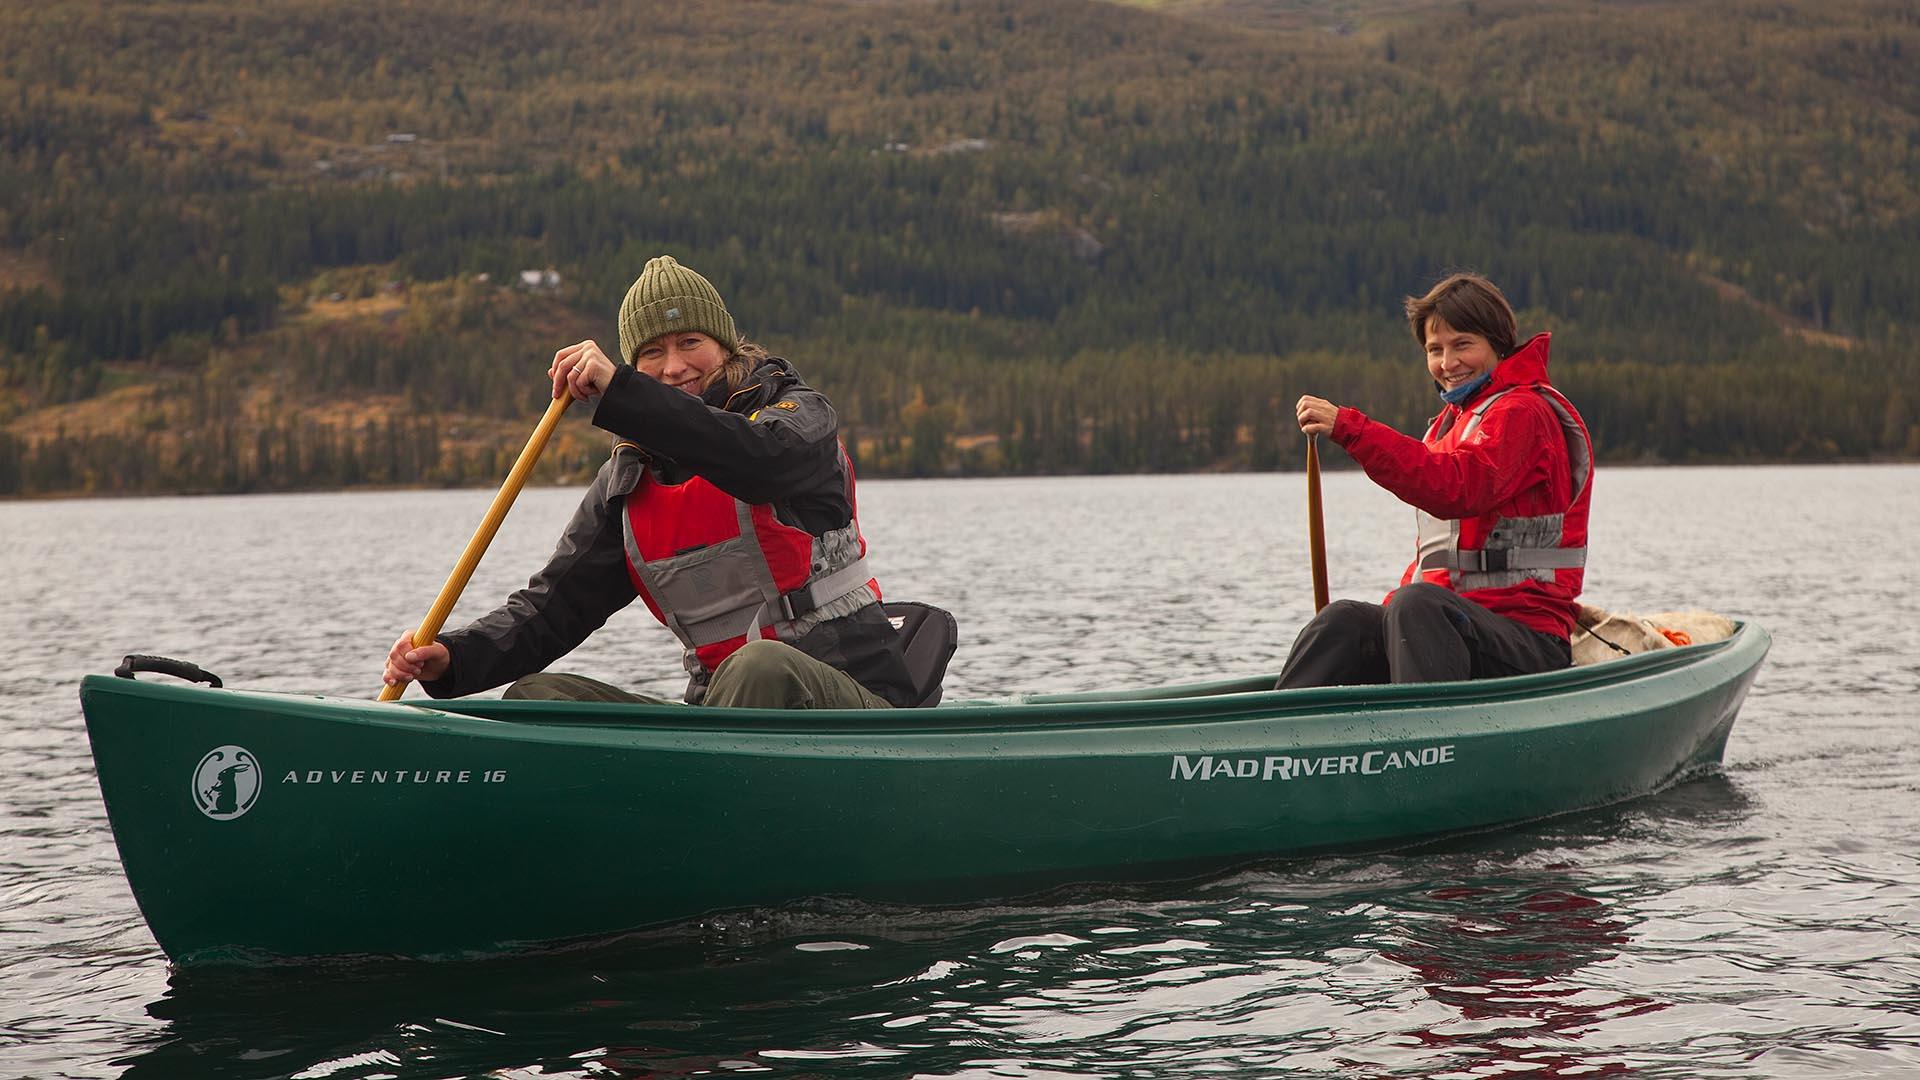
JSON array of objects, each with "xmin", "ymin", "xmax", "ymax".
[{"xmin": 0, "ymin": 467, "xmax": 1920, "ymax": 1080}]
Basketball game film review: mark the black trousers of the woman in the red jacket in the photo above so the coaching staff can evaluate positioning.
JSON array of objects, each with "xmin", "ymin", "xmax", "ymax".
[{"xmin": 1275, "ymin": 582, "xmax": 1572, "ymax": 690}]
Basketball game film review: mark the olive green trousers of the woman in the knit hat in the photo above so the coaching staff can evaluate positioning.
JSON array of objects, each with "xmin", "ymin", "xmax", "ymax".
[{"xmin": 505, "ymin": 640, "xmax": 891, "ymax": 709}]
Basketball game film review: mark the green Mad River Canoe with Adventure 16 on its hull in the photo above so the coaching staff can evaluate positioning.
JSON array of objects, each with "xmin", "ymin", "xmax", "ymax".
[{"xmin": 81, "ymin": 625, "xmax": 1770, "ymax": 965}]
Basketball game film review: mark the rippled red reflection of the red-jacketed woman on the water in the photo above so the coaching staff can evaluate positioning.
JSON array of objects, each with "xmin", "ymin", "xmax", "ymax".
[{"xmin": 1380, "ymin": 882, "xmax": 1667, "ymax": 1076}]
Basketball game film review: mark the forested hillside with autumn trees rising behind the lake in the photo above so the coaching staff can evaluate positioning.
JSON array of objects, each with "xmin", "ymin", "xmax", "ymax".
[{"xmin": 0, "ymin": 0, "xmax": 1920, "ymax": 494}]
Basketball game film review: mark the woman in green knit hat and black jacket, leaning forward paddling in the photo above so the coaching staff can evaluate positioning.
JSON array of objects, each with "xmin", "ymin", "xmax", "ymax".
[{"xmin": 386, "ymin": 256, "xmax": 927, "ymax": 709}]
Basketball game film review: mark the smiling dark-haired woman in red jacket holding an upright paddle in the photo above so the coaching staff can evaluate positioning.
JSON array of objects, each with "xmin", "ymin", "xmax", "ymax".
[{"xmin": 1279, "ymin": 273, "xmax": 1594, "ymax": 690}]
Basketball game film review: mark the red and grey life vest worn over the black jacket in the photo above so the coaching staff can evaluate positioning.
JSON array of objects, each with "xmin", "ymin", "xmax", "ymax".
[{"xmin": 622, "ymin": 452, "xmax": 879, "ymax": 684}]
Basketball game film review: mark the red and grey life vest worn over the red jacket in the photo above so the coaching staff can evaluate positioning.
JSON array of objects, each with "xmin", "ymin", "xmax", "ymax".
[{"xmin": 1407, "ymin": 382, "xmax": 1594, "ymax": 634}]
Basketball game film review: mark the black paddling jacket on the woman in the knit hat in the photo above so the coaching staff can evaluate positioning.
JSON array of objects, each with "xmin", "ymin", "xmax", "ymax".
[{"xmin": 420, "ymin": 357, "xmax": 914, "ymax": 705}]
